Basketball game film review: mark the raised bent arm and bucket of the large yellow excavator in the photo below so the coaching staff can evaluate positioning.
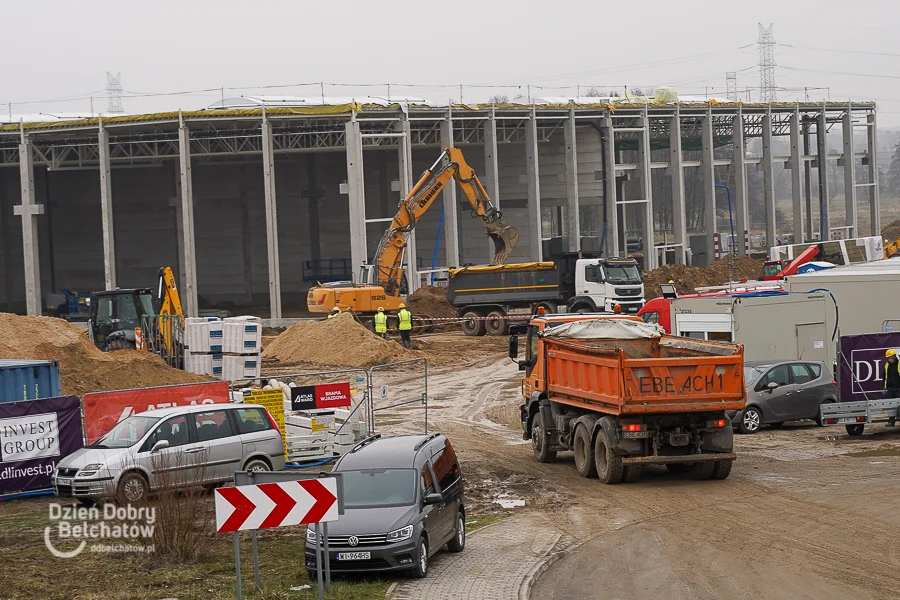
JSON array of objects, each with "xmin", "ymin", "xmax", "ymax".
[{"xmin": 375, "ymin": 148, "xmax": 519, "ymax": 296}]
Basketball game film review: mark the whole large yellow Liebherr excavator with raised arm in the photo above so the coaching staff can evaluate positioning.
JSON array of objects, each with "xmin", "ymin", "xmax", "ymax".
[{"xmin": 306, "ymin": 148, "xmax": 519, "ymax": 316}]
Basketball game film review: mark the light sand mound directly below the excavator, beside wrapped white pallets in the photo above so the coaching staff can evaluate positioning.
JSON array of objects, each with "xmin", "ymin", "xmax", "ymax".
[{"xmin": 263, "ymin": 313, "xmax": 420, "ymax": 367}]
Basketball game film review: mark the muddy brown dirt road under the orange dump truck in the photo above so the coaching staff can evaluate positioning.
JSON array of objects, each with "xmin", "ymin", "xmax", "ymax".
[{"xmin": 368, "ymin": 336, "xmax": 900, "ymax": 600}]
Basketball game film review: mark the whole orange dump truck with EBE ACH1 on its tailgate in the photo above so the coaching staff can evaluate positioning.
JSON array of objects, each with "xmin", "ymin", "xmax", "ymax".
[{"xmin": 509, "ymin": 315, "xmax": 746, "ymax": 483}]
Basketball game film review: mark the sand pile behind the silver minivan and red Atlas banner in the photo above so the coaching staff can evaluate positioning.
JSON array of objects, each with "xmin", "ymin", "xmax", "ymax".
[{"xmin": 0, "ymin": 313, "xmax": 209, "ymax": 396}]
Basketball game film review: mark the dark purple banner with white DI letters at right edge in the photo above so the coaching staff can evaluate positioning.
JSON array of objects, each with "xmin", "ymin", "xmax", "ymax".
[{"xmin": 838, "ymin": 332, "xmax": 900, "ymax": 402}]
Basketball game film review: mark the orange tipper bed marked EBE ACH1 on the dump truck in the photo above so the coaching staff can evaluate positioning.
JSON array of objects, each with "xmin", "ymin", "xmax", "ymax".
[{"xmin": 544, "ymin": 336, "xmax": 746, "ymax": 415}]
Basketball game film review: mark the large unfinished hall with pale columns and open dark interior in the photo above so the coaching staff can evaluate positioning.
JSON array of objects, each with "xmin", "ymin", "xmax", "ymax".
[{"xmin": 0, "ymin": 99, "xmax": 880, "ymax": 318}]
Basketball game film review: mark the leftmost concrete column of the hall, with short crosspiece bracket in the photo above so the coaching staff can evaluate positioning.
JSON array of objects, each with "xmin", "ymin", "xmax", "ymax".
[{"xmin": 13, "ymin": 133, "xmax": 44, "ymax": 316}]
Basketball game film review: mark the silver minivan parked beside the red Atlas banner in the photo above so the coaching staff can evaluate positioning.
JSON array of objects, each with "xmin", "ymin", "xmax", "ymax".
[{"xmin": 52, "ymin": 404, "xmax": 284, "ymax": 504}]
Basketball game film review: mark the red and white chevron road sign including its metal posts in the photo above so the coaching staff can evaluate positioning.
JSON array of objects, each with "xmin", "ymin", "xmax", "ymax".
[{"xmin": 215, "ymin": 471, "xmax": 344, "ymax": 600}]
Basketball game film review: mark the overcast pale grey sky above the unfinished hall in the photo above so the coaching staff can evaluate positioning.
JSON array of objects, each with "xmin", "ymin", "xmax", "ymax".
[{"xmin": 0, "ymin": 0, "xmax": 900, "ymax": 126}]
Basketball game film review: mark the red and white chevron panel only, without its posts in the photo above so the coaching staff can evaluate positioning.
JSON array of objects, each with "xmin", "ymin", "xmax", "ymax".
[{"xmin": 216, "ymin": 477, "xmax": 338, "ymax": 532}]
